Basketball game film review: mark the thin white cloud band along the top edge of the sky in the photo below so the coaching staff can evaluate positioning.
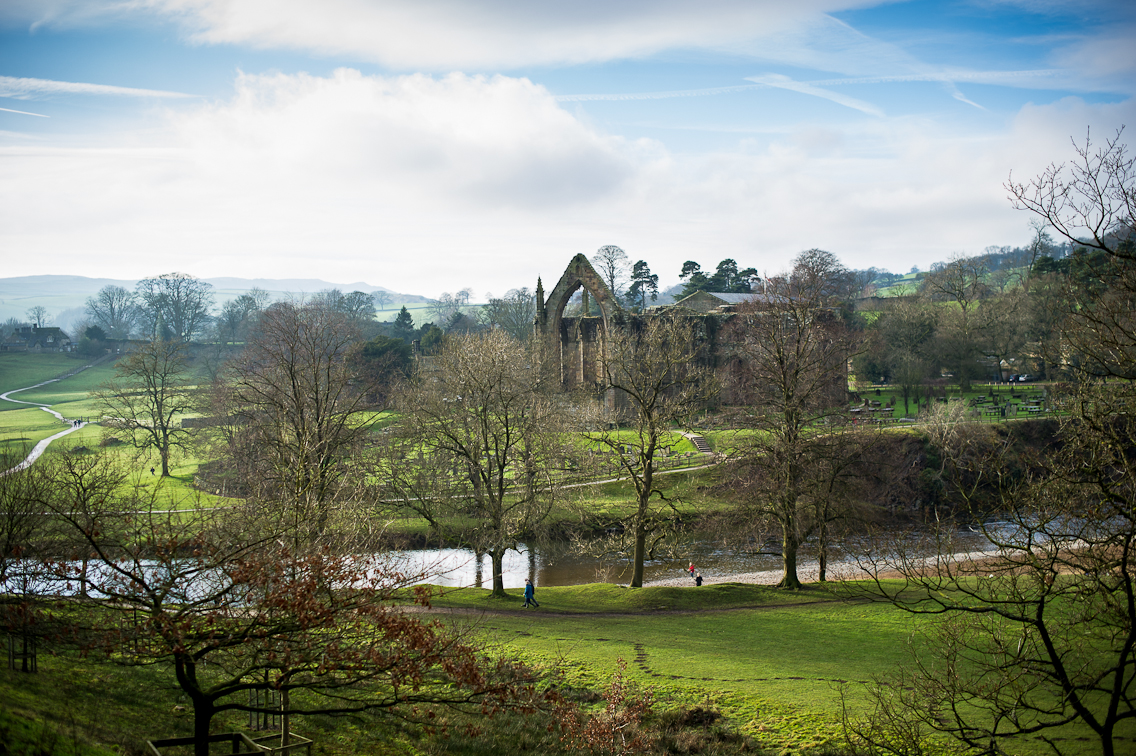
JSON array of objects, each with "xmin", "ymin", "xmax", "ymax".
[{"xmin": 0, "ymin": 0, "xmax": 874, "ymax": 70}]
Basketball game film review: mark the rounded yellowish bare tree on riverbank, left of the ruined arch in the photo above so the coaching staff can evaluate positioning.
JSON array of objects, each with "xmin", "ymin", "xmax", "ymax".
[{"xmin": 378, "ymin": 330, "xmax": 575, "ymax": 596}]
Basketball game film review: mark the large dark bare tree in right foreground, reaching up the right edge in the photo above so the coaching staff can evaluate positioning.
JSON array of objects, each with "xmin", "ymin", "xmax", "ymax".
[{"xmin": 849, "ymin": 126, "xmax": 1136, "ymax": 756}]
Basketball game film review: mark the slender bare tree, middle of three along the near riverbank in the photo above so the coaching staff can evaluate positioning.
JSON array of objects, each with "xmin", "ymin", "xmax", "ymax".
[{"xmin": 585, "ymin": 316, "xmax": 718, "ymax": 588}]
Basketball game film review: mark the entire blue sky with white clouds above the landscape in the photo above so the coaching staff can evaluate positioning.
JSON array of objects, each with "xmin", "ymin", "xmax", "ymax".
[{"xmin": 0, "ymin": 0, "xmax": 1136, "ymax": 299}]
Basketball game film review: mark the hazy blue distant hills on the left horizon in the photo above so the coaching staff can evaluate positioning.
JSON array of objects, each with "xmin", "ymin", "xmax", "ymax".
[{"xmin": 0, "ymin": 275, "xmax": 427, "ymax": 327}]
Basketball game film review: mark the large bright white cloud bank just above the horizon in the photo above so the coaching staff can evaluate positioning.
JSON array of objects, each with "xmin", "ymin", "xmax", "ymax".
[{"xmin": 0, "ymin": 69, "xmax": 1136, "ymax": 294}]
